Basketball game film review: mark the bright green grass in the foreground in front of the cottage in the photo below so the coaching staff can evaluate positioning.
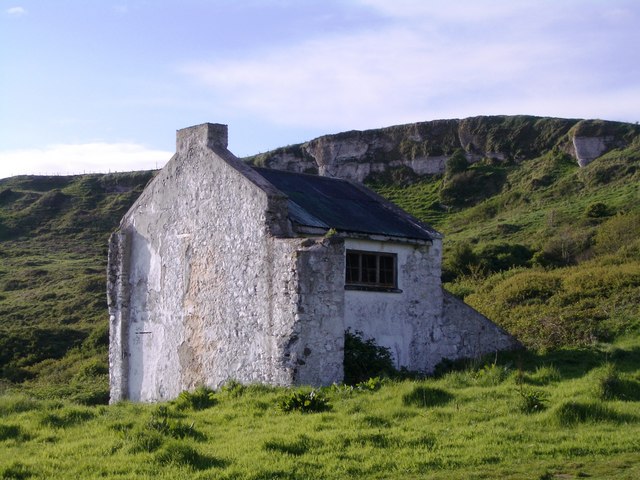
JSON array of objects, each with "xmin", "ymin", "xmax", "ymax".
[{"xmin": 0, "ymin": 339, "xmax": 640, "ymax": 479}]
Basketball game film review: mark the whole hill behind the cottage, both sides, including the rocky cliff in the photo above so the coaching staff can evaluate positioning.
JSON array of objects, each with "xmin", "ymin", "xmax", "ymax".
[{"xmin": 0, "ymin": 117, "xmax": 640, "ymax": 403}]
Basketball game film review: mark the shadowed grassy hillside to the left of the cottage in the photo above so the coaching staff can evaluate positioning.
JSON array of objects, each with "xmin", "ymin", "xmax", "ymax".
[{"xmin": 0, "ymin": 172, "xmax": 152, "ymax": 403}]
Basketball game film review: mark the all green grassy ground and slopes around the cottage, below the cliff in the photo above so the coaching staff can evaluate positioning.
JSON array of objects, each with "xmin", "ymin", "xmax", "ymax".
[{"xmin": 0, "ymin": 119, "xmax": 640, "ymax": 479}]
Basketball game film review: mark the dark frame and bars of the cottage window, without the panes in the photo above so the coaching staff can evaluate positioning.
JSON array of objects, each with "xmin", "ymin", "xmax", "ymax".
[{"xmin": 344, "ymin": 249, "xmax": 402, "ymax": 293}]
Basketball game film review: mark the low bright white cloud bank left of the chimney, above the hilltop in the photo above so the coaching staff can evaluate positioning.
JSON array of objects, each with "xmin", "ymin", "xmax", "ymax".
[{"xmin": 0, "ymin": 142, "xmax": 173, "ymax": 178}]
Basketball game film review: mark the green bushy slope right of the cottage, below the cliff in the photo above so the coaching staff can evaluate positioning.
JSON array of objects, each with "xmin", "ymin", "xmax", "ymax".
[{"xmin": 371, "ymin": 140, "xmax": 640, "ymax": 349}]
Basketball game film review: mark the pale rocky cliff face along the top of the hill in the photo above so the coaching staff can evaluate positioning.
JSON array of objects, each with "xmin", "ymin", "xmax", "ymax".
[{"xmin": 247, "ymin": 116, "xmax": 640, "ymax": 182}]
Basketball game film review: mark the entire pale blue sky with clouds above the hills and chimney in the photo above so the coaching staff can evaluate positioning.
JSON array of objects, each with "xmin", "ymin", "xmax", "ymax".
[{"xmin": 0, "ymin": 0, "xmax": 640, "ymax": 178}]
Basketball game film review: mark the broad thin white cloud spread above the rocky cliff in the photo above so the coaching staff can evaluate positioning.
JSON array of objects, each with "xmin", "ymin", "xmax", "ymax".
[{"xmin": 181, "ymin": 0, "xmax": 640, "ymax": 129}]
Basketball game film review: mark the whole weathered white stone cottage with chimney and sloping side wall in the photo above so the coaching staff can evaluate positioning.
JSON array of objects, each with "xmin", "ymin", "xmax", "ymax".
[{"xmin": 108, "ymin": 123, "xmax": 517, "ymax": 402}]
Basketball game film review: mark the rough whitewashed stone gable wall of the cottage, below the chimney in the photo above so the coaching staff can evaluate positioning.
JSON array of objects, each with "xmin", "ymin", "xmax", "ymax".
[{"xmin": 109, "ymin": 138, "xmax": 297, "ymax": 401}]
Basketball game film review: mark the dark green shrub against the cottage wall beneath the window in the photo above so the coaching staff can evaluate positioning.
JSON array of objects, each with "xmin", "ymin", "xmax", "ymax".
[{"xmin": 344, "ymin": 329, "xmax": 396, "ymax": 385}]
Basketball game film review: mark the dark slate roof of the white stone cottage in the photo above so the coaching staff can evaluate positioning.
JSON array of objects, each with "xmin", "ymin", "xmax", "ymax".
[{"xmin": 254, "ymin": 167, "xmax": 439, "ymax": 240}]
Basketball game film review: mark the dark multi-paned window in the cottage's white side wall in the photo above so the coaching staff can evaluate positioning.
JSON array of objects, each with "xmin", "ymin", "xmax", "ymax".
[{"xmin": 345, "ymin": 250, "xmax": 398, "ymax": 291}]
